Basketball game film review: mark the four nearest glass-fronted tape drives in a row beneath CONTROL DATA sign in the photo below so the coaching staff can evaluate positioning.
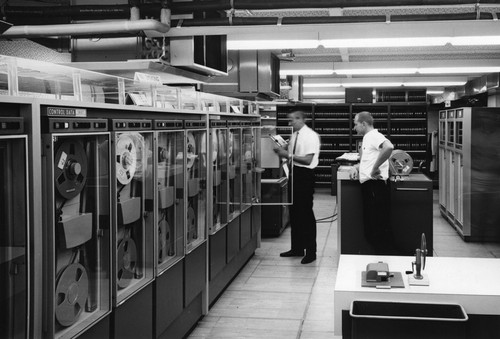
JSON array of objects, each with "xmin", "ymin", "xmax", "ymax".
[{"xmin": 43, "ymin": 118, "xmax": 207, "ymax": 337}]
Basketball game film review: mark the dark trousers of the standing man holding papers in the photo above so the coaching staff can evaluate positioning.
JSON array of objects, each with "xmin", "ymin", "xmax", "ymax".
[{"xmin": 290, "ymin": 166, "xmax": 316, "ymax": 254}]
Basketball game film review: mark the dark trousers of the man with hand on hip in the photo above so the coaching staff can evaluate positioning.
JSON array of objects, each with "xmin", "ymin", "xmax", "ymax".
[{"xmin": 361, "ymin": 180, "xmax": 395, "ymax": 254}]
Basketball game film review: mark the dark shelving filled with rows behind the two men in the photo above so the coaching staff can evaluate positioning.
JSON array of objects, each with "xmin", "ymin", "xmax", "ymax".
[{"xmin": 276, "ymin": 102, "xmax": 427, "ymax": 187}]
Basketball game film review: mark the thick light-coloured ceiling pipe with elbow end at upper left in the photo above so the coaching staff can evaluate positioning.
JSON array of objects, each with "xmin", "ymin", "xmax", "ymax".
[{"xmin": 0, "ymin": 19, "xmax": 170, "ymax": 38}]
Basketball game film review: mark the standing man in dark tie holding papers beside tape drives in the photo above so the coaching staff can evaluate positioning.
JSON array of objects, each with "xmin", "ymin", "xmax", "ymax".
[{"xmin": 274, "ymin": 110, "xmax": 320, "ymax": 264}]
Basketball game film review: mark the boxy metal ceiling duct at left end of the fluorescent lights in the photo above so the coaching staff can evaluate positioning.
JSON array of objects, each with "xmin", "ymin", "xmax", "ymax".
[{"xmin": 202, "ymin": 50, "xmax": 280, "ymax": 100}]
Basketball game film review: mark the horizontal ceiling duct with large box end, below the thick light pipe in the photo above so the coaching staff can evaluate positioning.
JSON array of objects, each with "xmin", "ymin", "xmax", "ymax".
[{"xmin": 71, "ymin": 36, "xmax": 223, "ymax": 84}]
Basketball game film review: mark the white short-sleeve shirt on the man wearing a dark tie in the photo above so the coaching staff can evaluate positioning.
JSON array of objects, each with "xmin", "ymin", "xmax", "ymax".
[{"xmin": 288, "ymin": 125, "xmax": 320, "ymax": 169}]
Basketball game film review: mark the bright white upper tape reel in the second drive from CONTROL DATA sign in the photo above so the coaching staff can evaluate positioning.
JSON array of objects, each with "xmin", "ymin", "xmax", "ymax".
[{"xmin": 116, "ymin": 134, "xmax": 137, "ymax": 185}]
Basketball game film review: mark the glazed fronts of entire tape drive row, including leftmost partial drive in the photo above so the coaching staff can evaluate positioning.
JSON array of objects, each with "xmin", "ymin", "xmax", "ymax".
[{"xmin": 0, "ymin": 106, "xmax": 256, "ymax": 338}]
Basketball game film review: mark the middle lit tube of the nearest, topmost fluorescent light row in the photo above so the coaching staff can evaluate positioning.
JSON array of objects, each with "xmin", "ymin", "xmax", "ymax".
[{"xmin": 320, "ymin": 37, "xmax": 450, "ymax": 48}]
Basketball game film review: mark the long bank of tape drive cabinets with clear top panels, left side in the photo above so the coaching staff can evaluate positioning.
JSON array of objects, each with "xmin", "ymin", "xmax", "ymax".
[{"xmin": 0, "ymin": 56, "xmax": 260, "ymax": 338}]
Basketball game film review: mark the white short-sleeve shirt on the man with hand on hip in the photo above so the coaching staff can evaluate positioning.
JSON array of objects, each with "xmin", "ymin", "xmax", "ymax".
[{"xmin": 359, "ymin": 129, "xmax": 389, "ymax": 183}]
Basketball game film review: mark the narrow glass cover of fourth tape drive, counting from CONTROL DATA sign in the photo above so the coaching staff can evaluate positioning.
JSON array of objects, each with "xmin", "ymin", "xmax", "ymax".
[{"xmin": 185, "ymin": 130, "xmax": 209, "ymax": 253}]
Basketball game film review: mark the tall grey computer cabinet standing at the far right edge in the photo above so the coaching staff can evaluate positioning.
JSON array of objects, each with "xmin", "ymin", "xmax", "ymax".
[{"xmin": 439, "ymin": 107, "xmax": 500, "ymax": 241}]
